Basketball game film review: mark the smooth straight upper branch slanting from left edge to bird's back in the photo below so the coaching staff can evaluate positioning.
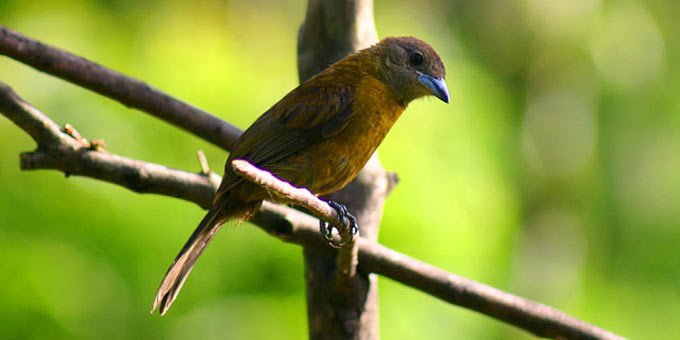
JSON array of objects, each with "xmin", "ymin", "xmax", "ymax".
[{"xmin": 0, "ymin": 25, "xmax": 241, "ymax": 150}]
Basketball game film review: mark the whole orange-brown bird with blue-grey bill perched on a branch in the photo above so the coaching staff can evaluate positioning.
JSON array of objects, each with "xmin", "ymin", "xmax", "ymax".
[{"xmin": 151, "ymin": 37, "xmax": 449, "ymax": 315}]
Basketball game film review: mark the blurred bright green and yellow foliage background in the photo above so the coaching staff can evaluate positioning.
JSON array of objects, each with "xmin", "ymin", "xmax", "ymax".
[{"xmin": 0, "ymin": 0, "xmax": 680, "ymax": 339}]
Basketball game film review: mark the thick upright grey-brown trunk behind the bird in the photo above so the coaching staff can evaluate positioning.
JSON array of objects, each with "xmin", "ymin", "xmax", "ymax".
[{"xmin": 298, "ymin": 0, "xmax": 394, "ymax": 339}]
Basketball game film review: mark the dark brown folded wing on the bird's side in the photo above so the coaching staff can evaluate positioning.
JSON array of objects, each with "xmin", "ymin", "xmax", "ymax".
[{"xmin": 217, "ymin": 82, "xmax": 355, "ymax": 197}]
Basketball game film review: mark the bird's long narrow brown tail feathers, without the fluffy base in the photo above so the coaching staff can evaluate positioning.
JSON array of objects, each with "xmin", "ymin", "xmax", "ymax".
[{"xmin": 151, "ymin": 202, "xmax": 225, "ymax": 315}]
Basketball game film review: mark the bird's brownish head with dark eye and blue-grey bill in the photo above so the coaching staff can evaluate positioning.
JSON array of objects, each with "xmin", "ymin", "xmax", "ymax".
[{"xmin": 376, "ymin": 37, "xmax": 449, "ymax": 104}]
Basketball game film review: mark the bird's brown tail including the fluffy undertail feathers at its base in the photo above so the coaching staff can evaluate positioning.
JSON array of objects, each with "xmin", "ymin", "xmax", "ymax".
[{"xmin": 151, "ymin": 199, "xmax": 261, "ymax": 315}]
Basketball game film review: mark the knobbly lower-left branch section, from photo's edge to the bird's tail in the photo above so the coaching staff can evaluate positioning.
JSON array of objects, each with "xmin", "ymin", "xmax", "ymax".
[{"xmin": 0, "ymin": 82, "xmax": 219, "ymax": 208}]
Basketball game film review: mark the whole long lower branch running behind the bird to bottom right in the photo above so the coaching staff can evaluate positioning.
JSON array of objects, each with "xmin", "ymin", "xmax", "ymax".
[{"xmin": 0, "ymin": 83, "xmax": 621, "ymax": 339}]
